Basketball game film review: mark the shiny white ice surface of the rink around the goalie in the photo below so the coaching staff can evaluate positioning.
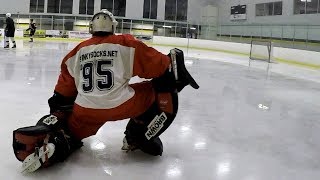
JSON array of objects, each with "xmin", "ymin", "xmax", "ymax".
[{"xmin": 0, "ymin": 41, "xmax": 320, "ymax": 180}]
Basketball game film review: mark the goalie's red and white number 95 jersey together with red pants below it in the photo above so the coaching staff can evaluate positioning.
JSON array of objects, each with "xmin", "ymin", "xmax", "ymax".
[{"xmin": 55, "ymin": 35, "xmax": 170, "ymax": 139}]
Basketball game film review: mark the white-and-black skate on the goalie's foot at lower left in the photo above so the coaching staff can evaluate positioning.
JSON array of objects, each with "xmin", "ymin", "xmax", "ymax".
[{"xmin": 22, "ymin": 143, "xmax": 55, "ymax": 173}]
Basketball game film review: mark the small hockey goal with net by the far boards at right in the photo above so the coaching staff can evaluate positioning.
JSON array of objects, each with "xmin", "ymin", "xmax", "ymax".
[{"xmin": 250, "ymin": 40, "xmax": 273, "ymax": 63}]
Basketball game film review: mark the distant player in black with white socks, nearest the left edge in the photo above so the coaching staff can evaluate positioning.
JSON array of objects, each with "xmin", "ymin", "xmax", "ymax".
[{"xmin": 4, "ymin": 13, "xmax": 17, "ymax": 48}]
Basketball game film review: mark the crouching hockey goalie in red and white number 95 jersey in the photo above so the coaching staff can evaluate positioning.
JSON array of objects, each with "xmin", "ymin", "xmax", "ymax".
[{"xmin": 13, "ymin": 10, "xmax": 199, "ymax": 172}]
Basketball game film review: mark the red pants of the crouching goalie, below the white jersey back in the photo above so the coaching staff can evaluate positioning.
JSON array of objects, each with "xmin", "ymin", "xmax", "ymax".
[{"xmin": 68, "ymin": 81, "xmax": 156, "ymax": 139}]
